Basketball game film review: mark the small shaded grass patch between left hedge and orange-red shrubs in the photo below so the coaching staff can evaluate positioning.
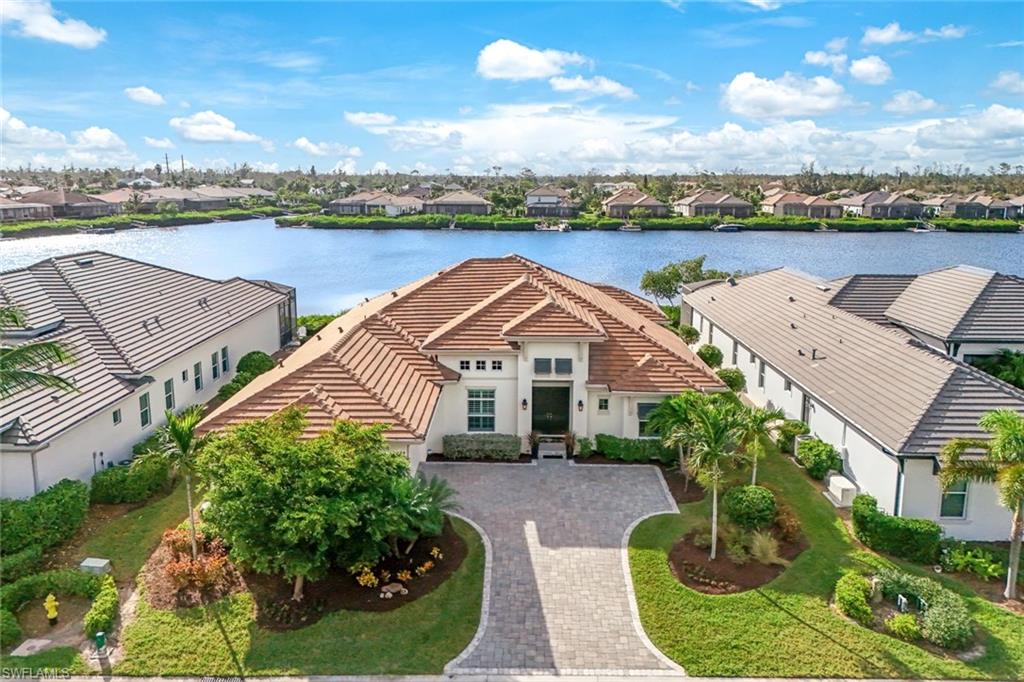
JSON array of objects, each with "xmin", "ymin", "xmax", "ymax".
[{"xmin": 76, "ymin": 483, "xmax": 191, "ymax": 583}]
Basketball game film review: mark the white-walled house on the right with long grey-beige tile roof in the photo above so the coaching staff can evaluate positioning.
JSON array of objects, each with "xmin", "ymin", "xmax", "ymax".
[{"xmin": 684, "ymin": 269, "xmax": 1024, "ymax": 540}]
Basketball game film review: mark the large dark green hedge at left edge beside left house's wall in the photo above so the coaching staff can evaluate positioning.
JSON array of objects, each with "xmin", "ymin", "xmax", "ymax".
[{"xmin": 0, "ymin": 479, "xmax": 89, "ymax": 555}]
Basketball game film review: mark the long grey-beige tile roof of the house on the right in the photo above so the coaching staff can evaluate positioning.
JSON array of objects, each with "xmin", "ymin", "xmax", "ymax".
[{"xmin": 686, "ymin": 269, "xmax": 1024, "ymax": 456}]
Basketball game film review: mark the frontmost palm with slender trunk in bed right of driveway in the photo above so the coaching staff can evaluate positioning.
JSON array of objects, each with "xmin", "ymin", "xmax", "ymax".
[{"xmin": 679, "ymin": 393, "xmax": 743, "ymax": 560}]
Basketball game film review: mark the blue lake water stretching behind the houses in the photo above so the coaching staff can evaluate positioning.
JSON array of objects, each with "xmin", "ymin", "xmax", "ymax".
[{"xmin": 0, "ymin": 219, "xmax": 1024, "ymax": 313}]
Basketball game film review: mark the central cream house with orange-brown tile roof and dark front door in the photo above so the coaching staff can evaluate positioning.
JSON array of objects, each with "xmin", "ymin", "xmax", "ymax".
[{"xmin": 204, "ymin": 255, "xmax": 725, "ymax": 469}]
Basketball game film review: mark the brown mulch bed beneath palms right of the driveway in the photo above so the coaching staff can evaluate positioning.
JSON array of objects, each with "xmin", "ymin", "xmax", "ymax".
[{"xmin": 669, "ymin": 528, "xmax": 807, "ymax": 594}]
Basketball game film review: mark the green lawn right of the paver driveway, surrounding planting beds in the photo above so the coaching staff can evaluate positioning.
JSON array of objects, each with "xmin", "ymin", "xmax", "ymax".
[{"xmin": 629, "ymin": 448, "xmax": 1024, "ymax": 679}]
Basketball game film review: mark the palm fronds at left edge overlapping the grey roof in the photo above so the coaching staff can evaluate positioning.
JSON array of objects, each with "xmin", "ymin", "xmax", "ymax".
[{"xmin": 0, "ymin": 305, "xmax": 75, "ymax": 399}]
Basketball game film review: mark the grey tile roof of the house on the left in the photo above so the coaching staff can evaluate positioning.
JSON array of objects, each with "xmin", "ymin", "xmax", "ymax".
[{"xmin": 0, "ymin": 251, "xmax": 288, "ymax": 445}]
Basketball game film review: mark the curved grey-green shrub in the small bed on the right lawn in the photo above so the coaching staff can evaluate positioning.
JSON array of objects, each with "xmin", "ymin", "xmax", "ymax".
[{"xmin": 878, "ymin": 568, "xmax": 974, "ymax": 649}]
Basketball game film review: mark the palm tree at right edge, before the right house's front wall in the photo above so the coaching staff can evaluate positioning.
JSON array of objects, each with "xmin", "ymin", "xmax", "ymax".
[{"xmin": 939, "ymin": 410, "xmax": 1024, "ymax": 599}]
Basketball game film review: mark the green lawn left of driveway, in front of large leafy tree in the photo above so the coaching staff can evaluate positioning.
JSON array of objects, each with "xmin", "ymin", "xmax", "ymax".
[{"xmin": 115, "ymin": 519, "xmax": 484, "ymax": 676}]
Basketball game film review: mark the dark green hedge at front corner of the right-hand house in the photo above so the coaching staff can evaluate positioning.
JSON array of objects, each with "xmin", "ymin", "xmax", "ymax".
[{"xmin": 852, "ymin": 495, "xmax": 942, "ymax": 563}]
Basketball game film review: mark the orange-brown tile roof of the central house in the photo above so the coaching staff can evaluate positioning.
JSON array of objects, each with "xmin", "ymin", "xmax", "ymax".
[{"xmin": 204, "ymin": 255, "xmax": 723, "ymax": 440}]
